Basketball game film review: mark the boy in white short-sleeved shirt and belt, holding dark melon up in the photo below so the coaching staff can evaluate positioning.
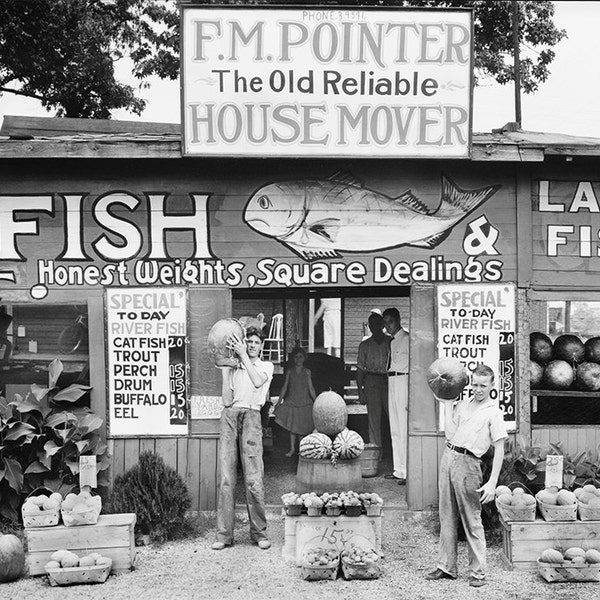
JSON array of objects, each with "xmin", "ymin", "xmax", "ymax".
[{"xmin": 425, "ymin": 365, "xmax": 508, "ymax": 587}]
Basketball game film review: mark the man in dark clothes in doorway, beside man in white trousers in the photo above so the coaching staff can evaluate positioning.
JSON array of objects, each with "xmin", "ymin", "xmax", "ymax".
[{"xmin": 356, "ymin": 312, "xmax": 390, "ymax": 448}]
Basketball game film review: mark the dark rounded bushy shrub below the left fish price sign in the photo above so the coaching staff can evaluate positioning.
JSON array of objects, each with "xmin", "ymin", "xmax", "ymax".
[{"xmin": 108, "ymin": 451, "xmax": 191, "ymax": 541}]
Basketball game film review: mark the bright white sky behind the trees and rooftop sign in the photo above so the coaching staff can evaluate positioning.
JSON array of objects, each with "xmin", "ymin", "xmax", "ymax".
[{"xmin": 0, "ymin": 1, "xmax": 600, "ymax": 138}]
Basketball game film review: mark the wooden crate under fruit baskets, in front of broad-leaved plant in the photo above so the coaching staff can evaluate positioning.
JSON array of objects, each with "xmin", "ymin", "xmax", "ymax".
[{"xmin": 25, "ymin": 513, "xmax": 136, "ymax": 575}]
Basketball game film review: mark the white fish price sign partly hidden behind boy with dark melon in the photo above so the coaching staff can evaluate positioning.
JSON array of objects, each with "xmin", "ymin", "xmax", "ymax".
[{"xmin": 437, "ymin": 283, "xmax": 516, "ymax": 431}]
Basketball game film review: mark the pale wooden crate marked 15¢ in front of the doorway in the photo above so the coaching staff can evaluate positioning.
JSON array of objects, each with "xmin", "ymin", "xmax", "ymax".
[{"xmin": 282, "ymin": 515, "xmax": 383, "ymax": 566}]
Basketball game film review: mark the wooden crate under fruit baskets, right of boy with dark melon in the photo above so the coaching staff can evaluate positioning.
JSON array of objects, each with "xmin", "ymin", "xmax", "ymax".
[{"xmin": 500, "ymin": 518, "xmax": 600, "ymax": 571}]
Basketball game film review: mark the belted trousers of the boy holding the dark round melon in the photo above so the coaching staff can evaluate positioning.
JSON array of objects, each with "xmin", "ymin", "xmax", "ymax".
[{"xmin": 438, "ymin": 448, "xmax": 485, "ymax": 579}]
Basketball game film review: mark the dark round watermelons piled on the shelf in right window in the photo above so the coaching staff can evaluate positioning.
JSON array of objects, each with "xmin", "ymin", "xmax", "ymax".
[{"xmin": 529, "ymin": 331, "xmax": 600, "ymax": 392}]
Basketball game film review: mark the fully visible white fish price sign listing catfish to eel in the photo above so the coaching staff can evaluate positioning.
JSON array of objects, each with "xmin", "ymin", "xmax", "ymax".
[{"xmin": 106, "ymin": 288, "xmax": 188, "ymax": 436}]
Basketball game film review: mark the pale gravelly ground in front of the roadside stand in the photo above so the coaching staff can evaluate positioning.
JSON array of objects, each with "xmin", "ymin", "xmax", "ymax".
[{"xmin": 0, "ymin": 511, "xmax": 600, "ymax": 600}]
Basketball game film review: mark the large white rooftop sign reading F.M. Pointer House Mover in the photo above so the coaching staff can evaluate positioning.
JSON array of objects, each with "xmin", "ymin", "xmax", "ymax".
[{"xmin": 181, "ymin": 5, "xmax": 472, "ymax": 158}]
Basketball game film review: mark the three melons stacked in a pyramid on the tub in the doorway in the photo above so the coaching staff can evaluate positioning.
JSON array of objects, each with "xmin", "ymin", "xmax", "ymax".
[{"xmin": 299, "ymin": 391, "xmax": 365, "ymax": 464}]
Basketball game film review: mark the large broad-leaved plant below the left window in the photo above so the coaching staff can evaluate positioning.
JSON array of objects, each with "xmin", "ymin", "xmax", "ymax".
[{"xmin": 0, "ymin": 359, "xmax": 110, "ymax": 521}]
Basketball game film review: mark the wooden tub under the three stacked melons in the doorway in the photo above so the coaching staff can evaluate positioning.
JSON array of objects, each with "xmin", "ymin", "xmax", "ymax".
[{"xmin": 296, "ymin": 456, "xmax": 363, "ymax": 494}]
